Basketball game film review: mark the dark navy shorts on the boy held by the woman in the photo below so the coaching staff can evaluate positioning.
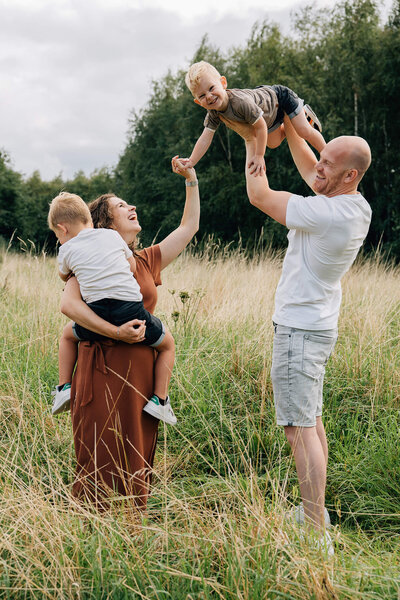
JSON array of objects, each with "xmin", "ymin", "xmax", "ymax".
[{"xmin": 72, "ymin": 298, "xmax": 165, "ymax": 348}]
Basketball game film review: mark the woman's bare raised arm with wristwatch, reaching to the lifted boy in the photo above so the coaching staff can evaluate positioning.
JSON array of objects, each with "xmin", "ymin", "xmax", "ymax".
[{"xmin": 159, "ymin": 156, "xmax": 200, "ymax": 269}]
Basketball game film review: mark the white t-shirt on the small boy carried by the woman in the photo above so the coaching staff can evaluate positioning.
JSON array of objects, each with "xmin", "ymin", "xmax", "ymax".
[{"xmin": 58, "ymin": 228, "xmax": 142, "ymax": 302}]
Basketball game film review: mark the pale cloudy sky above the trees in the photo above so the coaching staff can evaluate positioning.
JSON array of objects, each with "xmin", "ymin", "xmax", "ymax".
[{"xmin": 0, "ymin": 0, "xmax": 391, "ymax": 180}]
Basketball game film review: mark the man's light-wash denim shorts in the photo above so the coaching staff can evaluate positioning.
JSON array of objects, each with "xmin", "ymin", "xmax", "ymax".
[{"xmin": 271, "ymin": 323, "xmax": 337, "ymax": 427}]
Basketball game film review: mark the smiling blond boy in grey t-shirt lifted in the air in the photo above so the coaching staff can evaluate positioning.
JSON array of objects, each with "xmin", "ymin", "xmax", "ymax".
[{"xmin": 185, "ymin": 60, "xmax": 326, "ymax": 176}]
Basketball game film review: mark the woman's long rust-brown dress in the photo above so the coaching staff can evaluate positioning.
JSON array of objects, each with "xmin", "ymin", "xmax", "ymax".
[{"xmin": 71, "ymin": 245, "xmax": 161, "ymax": 508}]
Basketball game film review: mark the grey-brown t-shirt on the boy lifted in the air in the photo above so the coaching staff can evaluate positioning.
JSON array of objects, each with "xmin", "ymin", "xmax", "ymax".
[{"xmin": 204, "ymin": 85, "xmax": 278, "ymax": 131}]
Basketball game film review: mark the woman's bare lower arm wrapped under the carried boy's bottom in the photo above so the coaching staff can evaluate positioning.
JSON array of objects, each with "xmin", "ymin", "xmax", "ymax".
[{"xmin": 61, "ymin": 277, "xmax": 146, "ymax": 344}]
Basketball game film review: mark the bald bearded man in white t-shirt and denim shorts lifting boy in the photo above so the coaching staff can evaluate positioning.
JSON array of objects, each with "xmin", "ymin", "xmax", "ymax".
[{"xmin": 222, "ymin": 117, "xmax": 371, "ymax": 555}]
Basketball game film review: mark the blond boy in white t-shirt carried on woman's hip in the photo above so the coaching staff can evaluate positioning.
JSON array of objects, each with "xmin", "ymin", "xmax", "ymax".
[{"xmin": 48, "ymin": 192, "xmax": 176, "ymax": 425}]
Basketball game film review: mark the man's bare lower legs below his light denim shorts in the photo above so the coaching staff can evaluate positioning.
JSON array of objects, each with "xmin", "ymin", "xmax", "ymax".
[{"xmin": 285, "ymin": 424, "xmax": 327, "ymax": 528}]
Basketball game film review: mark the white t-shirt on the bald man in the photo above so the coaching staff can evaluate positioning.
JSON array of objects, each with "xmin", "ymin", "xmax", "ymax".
[{"xmin": 272, "ymin": 194, "xmax": 372, "ymax": 330}]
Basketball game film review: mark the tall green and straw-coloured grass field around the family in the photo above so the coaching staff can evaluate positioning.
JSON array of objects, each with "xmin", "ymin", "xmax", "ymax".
[{"xmin": 0, "ymin": 246, "xmax": 400, "ymax": 600}]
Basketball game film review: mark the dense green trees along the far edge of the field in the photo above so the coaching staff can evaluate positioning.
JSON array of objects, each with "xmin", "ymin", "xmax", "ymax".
[{"xmin": 0, "ymin": 0, "xmax": 400, "ymax": 260}]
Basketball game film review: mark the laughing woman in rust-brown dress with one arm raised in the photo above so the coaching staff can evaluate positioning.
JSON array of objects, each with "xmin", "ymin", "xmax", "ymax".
[{"xmin": 61, "ymin": 157, "xmax": 200, "ymax": 508}]
